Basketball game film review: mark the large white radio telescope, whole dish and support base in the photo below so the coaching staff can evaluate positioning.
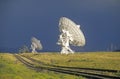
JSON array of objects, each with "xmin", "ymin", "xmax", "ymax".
[{"xmin": 57, "ymin": 17, "xmax": 85, "ymax": 54}]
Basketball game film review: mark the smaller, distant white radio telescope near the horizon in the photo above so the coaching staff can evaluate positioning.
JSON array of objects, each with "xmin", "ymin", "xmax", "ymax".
[{"xmin": 31, "ymin": 37, "xmax": 43, "ymax": 53}]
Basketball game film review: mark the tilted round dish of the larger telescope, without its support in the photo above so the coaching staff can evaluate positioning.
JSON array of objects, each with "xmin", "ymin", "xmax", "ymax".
[{"xmin": 59, "ymin": 17, "xmax": 85, "ymax": 46}]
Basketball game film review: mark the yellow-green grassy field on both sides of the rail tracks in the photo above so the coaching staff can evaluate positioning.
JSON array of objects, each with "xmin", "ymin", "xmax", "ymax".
[{"xmin": 0, "ymin": 52, "xmax": 120, "ymax": 79}]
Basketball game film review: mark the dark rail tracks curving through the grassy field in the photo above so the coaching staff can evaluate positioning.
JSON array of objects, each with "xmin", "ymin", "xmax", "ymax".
[{"xmin": 14, "ymin": 54, "xmax": 120, "ymax": 79}]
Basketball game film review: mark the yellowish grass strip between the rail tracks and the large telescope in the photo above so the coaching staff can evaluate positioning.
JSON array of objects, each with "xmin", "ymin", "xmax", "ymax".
[{"xmin": 24, "ymin": 52, "xmax": 120, "ymax": 70}]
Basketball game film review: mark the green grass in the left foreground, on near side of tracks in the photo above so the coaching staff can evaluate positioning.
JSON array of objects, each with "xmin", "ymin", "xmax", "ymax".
[{"xmin": 0, "ymin": 53, "xmax": 84, "ymax": 79}]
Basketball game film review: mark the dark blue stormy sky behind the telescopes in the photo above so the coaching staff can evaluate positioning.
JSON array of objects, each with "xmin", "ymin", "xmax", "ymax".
[{"xmin": 0, "ymin": 0, "xmax": 120, "ymax": 52}]
